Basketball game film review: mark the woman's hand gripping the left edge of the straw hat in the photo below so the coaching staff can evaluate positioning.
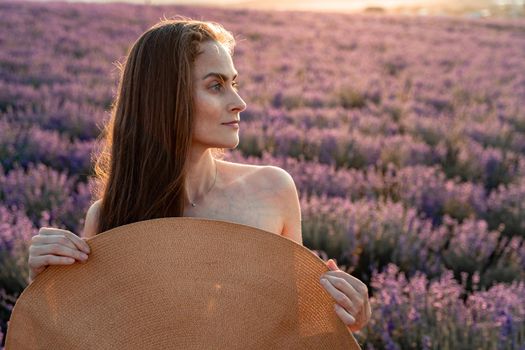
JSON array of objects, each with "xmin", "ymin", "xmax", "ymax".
[{"xmin": 28, "ymin": 227, "xmax": 90, "ymax": 282}]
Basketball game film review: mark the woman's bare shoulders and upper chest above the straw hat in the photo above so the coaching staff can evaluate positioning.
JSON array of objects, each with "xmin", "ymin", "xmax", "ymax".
[{"xmin": 83, "ymin": 160, "xmax": 302, "ymax": 245}]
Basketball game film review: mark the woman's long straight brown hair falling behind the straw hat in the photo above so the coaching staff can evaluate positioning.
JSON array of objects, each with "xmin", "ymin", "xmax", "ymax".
[{"xmin": 94, "ymin": 18, "xmax": 235, "ymax": 233}]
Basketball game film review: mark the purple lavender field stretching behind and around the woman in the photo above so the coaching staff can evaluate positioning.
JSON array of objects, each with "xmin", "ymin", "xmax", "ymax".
[{"xmin": 0, "ymin": 2, "xmax": 525, "ymax": 350}]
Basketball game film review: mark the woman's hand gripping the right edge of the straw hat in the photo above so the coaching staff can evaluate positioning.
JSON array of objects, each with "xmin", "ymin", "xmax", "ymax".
[{"xmin": 321, "ymin": 259, "xmax": 372, "ymax": 332}]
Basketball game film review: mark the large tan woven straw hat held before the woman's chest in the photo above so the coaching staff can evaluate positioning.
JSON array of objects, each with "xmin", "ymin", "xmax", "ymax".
[{"xmin": 6, "ymin": 217, "xmax": 360, "ymax": 350}]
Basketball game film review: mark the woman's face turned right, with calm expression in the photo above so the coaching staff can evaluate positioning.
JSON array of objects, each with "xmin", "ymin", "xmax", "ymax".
[{"xmin": 193, "ymin": 41, "xmax": 246, "ymax": 148}]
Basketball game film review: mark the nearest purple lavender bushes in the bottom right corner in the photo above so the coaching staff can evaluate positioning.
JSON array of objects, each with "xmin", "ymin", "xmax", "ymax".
[{"xmin": 357, "ymin": 264, "xmax": 525, "ymax": 349}]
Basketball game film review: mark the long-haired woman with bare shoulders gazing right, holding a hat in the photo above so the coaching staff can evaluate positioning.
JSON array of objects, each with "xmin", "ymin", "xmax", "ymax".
[{"xmin": 25, "ymin": 19, "xmax": 370, "ymax": 331}]
